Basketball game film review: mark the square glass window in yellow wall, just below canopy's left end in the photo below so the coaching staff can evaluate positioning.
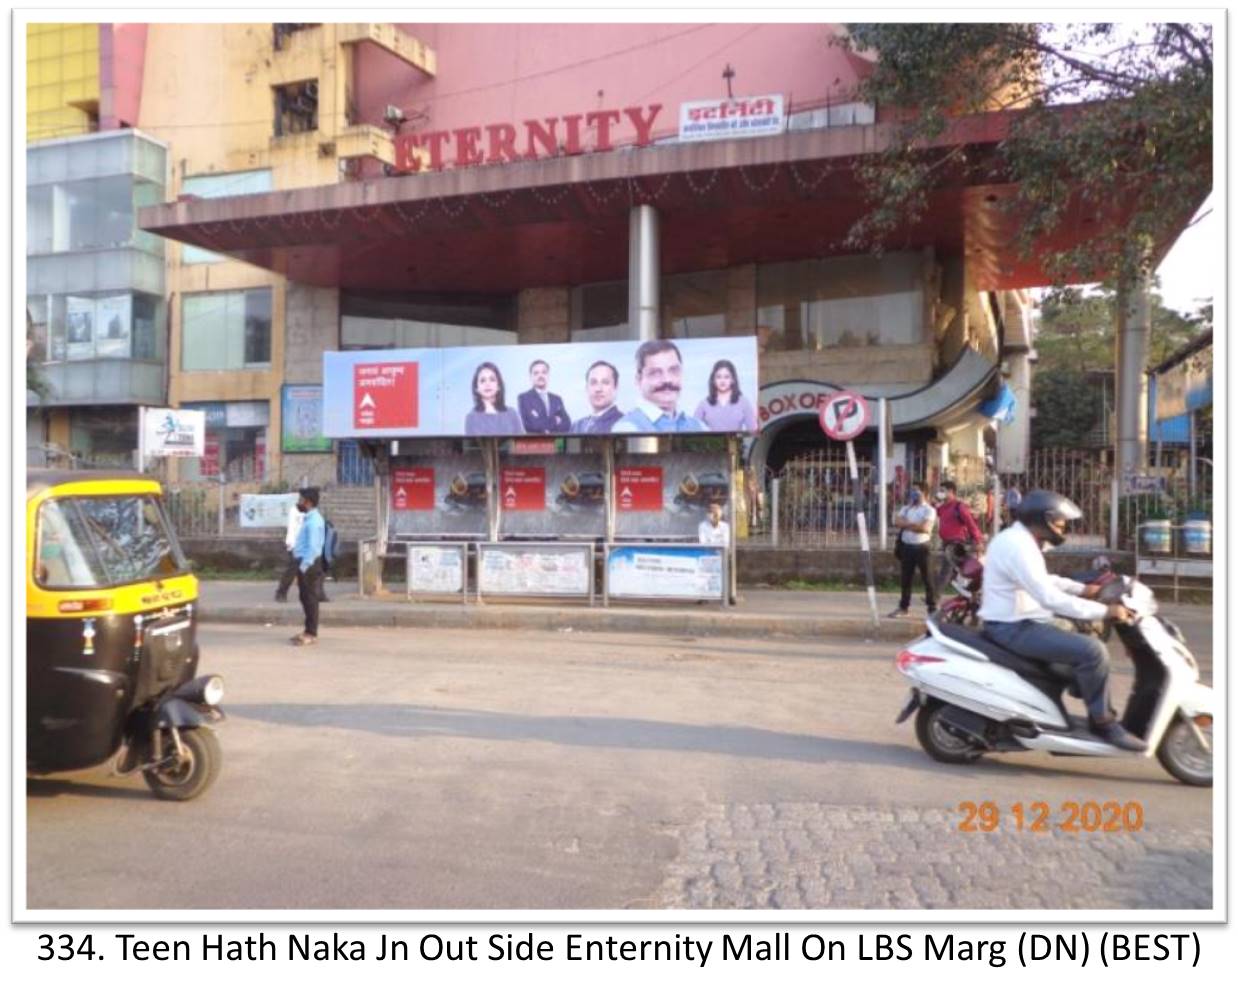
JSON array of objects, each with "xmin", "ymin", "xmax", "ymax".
[{"xmin": 181, "ymin": 287, "xmax": 271, "ymax": 370}]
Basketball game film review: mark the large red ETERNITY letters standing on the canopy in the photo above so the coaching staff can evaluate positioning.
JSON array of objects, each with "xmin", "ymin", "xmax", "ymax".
[{"xmin": 394, "ymin": 104, "xmax": 668, "ymax": 172}]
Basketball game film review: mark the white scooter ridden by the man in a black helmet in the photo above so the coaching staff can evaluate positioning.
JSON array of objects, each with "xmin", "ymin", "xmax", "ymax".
[{"xmin": 895, "ymin": 577, "xmax": 1214, "ymax": 787}]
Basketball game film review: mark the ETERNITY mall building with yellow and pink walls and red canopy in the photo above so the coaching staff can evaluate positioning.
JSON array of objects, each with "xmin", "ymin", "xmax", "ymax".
[{"xmin": 27, "ymin": 24, "xmax": 1047, "ymax": 497}]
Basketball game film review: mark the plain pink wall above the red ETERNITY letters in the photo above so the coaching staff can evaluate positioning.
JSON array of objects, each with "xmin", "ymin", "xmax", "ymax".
[{"xmin": 354, "ymin": 24, "xmax": 865, "ymax": 160}]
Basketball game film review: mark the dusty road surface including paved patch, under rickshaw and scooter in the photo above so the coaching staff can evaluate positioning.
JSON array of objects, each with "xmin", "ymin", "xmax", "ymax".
[{"xmin": 27, "ymin": 626, "xmax": 1213, "ymax": 910}]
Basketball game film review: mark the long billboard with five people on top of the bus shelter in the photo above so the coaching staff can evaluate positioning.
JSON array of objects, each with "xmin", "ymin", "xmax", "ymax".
[{"xmin": 323, "ymin": 337, "xmax": 759, "ymax": 439}]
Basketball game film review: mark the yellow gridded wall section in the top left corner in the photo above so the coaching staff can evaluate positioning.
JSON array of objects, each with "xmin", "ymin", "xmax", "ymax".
[{"xmin": 26, "ymin": 24, "xmax": 99, "ymax": 142}]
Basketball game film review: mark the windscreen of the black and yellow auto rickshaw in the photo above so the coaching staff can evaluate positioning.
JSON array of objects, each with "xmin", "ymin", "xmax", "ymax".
[{"xmin": 35, "ymin": 495, "xmax": 188, "ymax": 588}]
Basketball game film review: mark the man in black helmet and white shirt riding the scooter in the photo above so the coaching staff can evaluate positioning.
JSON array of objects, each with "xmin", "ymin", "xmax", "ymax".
[{"xmin": 979, "ymin": 490, "xmax": 1144, "ymax": 750}]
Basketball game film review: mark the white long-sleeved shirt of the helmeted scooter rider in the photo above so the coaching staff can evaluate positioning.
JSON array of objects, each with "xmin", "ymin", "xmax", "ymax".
[{"xmin": 979, "ymin": 522, "xmax": 1109, "ymax": 622}]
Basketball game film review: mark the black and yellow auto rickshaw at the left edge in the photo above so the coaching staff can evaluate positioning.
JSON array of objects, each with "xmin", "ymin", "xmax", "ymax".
[{"xmin": 26, "ymin": 470, "xmax": 224, "ymax": 801}]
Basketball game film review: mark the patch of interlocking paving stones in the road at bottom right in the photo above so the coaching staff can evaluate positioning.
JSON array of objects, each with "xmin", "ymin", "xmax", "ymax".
[{"xmin": 659, "ymin": 803, "xmax": 1212, "ymax": 910}]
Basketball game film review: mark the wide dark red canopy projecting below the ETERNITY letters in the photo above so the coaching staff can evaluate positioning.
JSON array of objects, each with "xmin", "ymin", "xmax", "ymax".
[{"xmin": 139, "ymin": 111, "xmax": 1203, "ymax": 293}]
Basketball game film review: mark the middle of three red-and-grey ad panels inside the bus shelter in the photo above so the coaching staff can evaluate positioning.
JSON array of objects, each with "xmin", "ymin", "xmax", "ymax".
[{"xmin": 499, "ymin": 455, "xmax": 607, "ymax": 537}]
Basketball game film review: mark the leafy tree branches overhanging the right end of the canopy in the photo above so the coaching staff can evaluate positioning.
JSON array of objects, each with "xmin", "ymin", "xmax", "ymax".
[{"xmin": 834, "ymin": 24, "xmax": 1212, "ymax": 285}]
